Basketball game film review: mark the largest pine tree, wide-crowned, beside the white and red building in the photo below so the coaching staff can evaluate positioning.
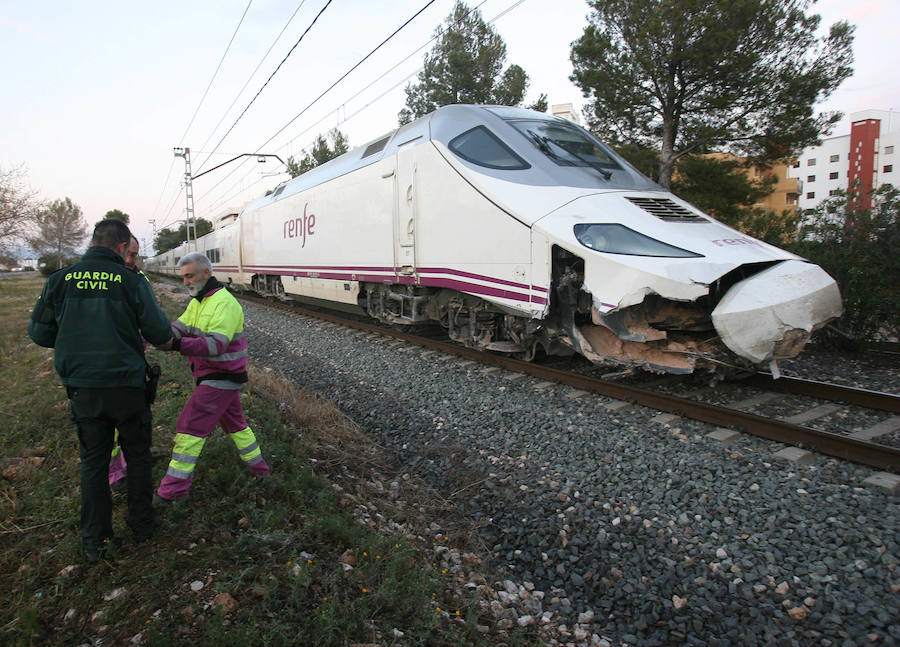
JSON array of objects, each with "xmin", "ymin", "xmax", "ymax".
[{"xmin": 571, "ymin": 0, "xmax": 854, "ymax": 188}]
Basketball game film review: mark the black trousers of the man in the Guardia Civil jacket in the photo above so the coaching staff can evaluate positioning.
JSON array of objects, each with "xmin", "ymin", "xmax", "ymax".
[{"xmin": 69, "ymin": 387, "xmax": 154, "ymax": 548}]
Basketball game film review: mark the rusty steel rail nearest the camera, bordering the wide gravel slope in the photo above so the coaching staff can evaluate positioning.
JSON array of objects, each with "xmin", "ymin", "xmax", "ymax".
[{"xmin": 241, "ymin": 294, "xmax": 900, "ymax": 472}]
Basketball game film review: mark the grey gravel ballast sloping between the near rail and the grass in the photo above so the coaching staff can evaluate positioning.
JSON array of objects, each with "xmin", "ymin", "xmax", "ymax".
[{"xmin": 244, "ymin": 302, "xmax": 900, "ymax": 646}]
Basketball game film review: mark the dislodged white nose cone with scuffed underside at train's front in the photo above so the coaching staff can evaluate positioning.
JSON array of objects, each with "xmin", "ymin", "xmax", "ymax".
[{"xmin": 712, "ymin": 260, "xmax": 842, "ymax": 364}]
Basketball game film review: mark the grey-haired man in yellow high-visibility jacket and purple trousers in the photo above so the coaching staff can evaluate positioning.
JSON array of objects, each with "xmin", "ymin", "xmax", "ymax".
[{"xmin": 154, "ymin": 252, "xmax": 269, "ymax": 505}]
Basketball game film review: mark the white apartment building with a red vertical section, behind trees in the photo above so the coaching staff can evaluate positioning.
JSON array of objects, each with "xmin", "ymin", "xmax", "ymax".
[{"xmin": 788, "ymin": 110, "xmax": 900, "ymax": 211}]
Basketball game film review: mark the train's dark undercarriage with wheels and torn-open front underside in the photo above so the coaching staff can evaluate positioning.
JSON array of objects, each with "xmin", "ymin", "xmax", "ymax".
[{"xmin": 252, "ymin": 247, "xmax": 828, "ymax": 375}]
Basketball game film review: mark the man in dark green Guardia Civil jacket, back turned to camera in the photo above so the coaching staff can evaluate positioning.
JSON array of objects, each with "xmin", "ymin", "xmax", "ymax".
[{"xmin": 28, "ymin": 220, "xmax": 172, "ymax": 562}]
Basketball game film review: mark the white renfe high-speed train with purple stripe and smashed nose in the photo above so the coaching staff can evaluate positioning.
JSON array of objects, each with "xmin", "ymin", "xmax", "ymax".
[{"xmin": 147, "ymin": 105, "xmax": 841, "ymax": 373}]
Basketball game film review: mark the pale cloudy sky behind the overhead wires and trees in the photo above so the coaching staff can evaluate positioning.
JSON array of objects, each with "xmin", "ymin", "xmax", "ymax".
[{"xmin": 0, "ymin": 0, "xmax": 900, "ymax": 254}]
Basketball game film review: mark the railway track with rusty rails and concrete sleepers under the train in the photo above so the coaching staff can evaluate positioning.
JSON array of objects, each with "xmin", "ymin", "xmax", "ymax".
[{"xmin": 239, "ymin": 294, "xmax": 900, "ymax": 473}]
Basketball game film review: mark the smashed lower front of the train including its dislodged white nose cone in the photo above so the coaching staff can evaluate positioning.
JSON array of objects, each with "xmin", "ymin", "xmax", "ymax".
[{"xmin": 559, "ymin": 253, "xmax": 841, "ymax": 373}]
